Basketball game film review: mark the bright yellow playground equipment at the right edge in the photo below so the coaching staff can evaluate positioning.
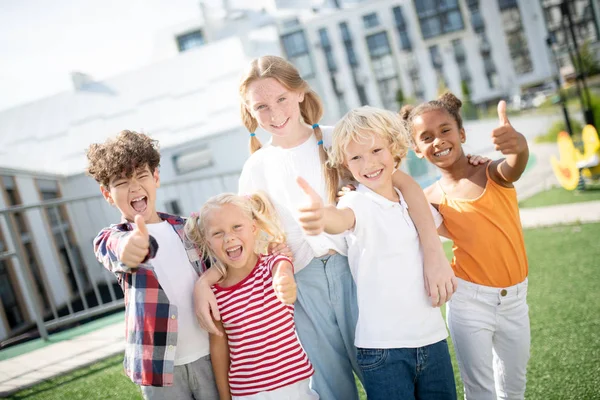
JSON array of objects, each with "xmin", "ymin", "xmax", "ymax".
[{"xmin": 550, "ymin": 125, "xmax": 600, "ymax": 190}]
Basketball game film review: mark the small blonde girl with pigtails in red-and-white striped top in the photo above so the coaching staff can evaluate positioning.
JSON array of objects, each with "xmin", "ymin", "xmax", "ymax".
[{"xmin": 185, "ymin": 193, "xmax": 319, "ymax": 400}]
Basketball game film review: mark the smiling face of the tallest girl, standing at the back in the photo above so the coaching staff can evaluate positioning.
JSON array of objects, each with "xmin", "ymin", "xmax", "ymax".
[{"xmin": 246, "ymin": 78, "xmax": 304, "ymax": 139}]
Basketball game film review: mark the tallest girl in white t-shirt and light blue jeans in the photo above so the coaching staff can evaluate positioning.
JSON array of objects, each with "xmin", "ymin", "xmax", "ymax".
[{"xmin": 195, "ymin": 56, "xmax": 454, "ymax": 400}]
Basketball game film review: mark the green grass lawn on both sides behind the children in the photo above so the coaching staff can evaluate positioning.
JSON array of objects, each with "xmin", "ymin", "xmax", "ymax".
[{"xmin": 5, "ymin": 223, "xmax": 600, "ymax": 400}]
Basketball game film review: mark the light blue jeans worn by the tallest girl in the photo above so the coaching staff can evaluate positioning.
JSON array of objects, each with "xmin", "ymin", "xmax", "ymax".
[{"xmin": 295, "ymin": 254, "xmax": 362, "ymax": 400}]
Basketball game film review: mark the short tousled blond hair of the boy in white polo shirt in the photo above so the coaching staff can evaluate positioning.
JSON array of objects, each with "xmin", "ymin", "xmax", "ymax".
[{"xmin": 327, "ymin": 106, "xmax": 410, "ymax": 202}]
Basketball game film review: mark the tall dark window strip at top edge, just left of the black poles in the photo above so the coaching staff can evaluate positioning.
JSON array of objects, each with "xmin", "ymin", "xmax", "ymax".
[{"xmin": 499, "ymin": 0, "xmax": 533, "ymax": 75}]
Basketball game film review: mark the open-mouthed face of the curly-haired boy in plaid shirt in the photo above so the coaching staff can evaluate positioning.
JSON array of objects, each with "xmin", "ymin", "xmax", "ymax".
[{"xmin": 100, "ymin": 165, "xmax": 160, "ymax": 224}]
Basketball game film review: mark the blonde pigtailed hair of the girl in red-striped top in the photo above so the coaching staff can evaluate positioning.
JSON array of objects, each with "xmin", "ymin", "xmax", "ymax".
[{"xmin": 184, "ymin": 192, "xmax": 285, "ymax": 278}]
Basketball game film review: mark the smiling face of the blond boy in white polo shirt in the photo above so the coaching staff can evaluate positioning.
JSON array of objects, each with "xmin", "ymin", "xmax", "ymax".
[{"xmin": 345, "ymin": 134, "xmax": 396, "ymax": 194}]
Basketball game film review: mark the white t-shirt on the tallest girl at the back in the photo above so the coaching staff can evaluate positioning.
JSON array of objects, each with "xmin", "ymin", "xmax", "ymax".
[{"xmin": 239, "ymin": 127, "xmax": 346, "ymax": 272}]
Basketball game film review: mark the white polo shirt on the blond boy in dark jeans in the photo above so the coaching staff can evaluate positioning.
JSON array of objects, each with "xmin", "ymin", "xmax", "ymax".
[{"xmin": 338, "ymin": 185, "xmax": 448, "ymax": 349}]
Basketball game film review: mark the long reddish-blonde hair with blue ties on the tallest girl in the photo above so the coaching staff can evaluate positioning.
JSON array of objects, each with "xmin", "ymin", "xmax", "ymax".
[{"xmin": 239, "ymin": 56, "xmax": 339, "ymax": 203}]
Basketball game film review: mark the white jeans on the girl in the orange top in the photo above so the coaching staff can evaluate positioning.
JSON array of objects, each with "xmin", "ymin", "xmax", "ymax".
[{"xmin": 447, "ymin": 279, "xmax": 531, "ymax": 400}]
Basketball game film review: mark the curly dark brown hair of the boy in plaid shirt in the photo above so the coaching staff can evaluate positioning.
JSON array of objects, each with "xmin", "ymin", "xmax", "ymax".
[{"xmin": 86, "ymin": 130, "xmax": 160, "ymax": 187}]
